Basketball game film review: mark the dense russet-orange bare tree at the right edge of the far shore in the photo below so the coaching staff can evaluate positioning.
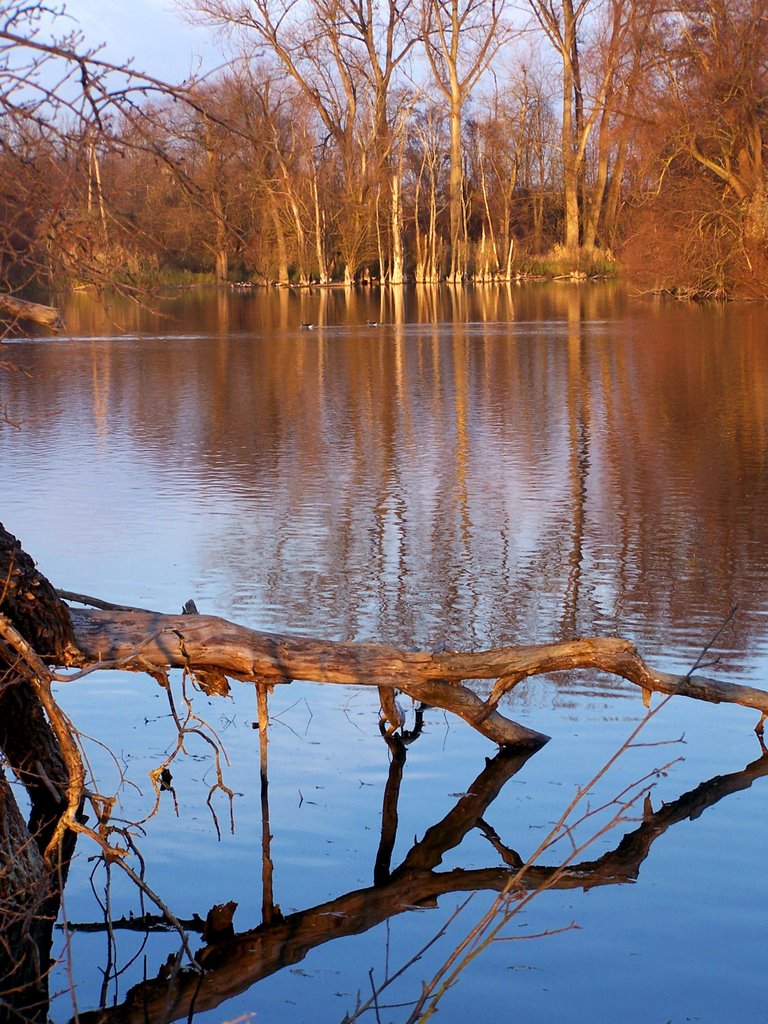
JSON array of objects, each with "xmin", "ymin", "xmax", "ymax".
[{"xmin": 627, "ymin": 0, "xmax": 768, "ymax": 297}]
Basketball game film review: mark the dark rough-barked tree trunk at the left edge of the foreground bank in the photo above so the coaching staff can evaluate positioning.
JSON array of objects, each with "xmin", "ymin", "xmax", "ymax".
[{"xmin": 0, "ymin": 523, "xmax": 80, "ymax": 1021}]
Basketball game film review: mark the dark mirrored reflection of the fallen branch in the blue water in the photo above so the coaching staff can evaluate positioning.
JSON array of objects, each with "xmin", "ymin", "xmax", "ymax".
[{"xmin": 69, "ymin": 738, "xmax": 768, "ymax": 1024}]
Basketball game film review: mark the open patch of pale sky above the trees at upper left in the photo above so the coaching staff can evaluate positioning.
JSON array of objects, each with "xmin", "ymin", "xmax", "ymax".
[{"xmin": 61, "ymin": 0, "xmax": 222, "ymax": 83}]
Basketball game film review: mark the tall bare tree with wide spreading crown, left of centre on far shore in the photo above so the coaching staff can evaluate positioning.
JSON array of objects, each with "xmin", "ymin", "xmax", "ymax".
[{"xmin": 190, "ymin": 0, "xmax": 415, "ymax": 283}]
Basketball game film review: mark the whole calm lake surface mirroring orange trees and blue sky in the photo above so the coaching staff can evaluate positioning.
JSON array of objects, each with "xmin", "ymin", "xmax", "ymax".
[{"xmin": 0, "ymin": 283, "xmax": 768, "ymax": 1024}]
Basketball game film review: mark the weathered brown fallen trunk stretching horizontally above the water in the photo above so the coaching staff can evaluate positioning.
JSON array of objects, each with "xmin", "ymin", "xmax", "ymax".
[{"xmin": 60, "ymin": 592, "xmax": 768, "ymax": 748}]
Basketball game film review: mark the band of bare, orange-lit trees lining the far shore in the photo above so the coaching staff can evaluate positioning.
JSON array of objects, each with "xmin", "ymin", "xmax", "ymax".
[{"xmin": 0, "ymin": 0, "xmax": 768, "ymax": 296}]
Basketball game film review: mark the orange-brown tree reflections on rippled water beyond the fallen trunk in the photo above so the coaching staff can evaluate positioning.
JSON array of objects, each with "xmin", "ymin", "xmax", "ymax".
[{"xmin": 6, "ymin": 286, "xmax": 768, "ymax": 672}]
